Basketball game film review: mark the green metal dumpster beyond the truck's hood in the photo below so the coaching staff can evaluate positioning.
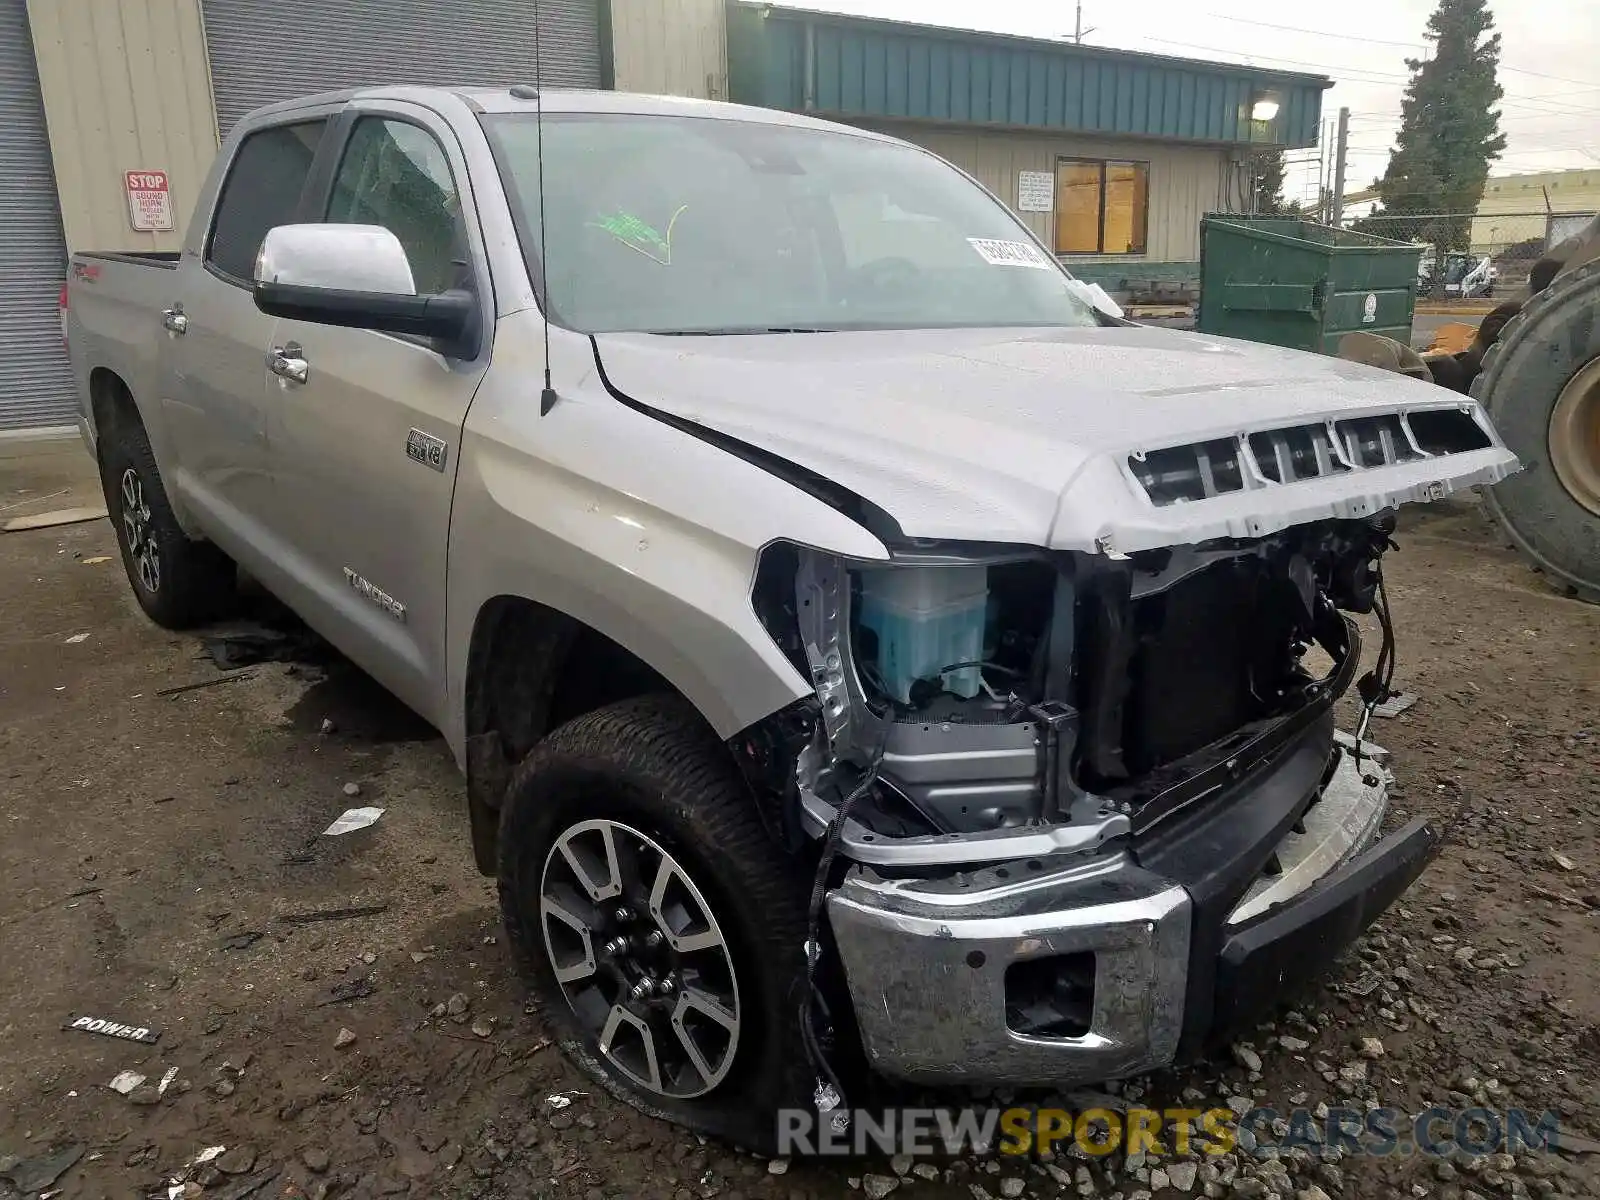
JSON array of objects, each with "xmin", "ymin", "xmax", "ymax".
[{"xmin": 1197, "ymin": 213, "xmax": 1422, "ymax": 354}]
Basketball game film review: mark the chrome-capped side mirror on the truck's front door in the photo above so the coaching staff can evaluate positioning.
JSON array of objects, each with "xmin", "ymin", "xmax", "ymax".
[{"xmin": 254, "ymin": 224, "xmax": 478, "ymax": 350}]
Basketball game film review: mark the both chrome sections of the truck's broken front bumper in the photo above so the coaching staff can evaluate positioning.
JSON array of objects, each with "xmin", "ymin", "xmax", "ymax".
[{"xmin": 827, "ymin": 734, "xmax": 1401, "ymax": 1083}]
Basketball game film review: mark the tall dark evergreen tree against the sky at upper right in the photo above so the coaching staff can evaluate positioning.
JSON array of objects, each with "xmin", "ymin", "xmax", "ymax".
[{"xmin": 1368, "ymin": 0, "xmax": 1506, "ymax": 262}]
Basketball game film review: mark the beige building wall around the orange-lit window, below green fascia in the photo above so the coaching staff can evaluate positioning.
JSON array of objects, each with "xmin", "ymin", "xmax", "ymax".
[{"xmin": 853, "ymin": 122, "xmax": 1229, "ymax": 262}]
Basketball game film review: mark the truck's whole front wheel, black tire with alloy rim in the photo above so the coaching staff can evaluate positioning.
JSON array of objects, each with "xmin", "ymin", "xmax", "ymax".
[{"xmin": 499, "ymin": 696, "xmax": 806, "ymax": 1150}]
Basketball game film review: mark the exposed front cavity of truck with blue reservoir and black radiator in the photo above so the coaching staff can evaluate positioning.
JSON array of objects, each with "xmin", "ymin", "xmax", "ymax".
[{"xmin": 755, "ymin": 512, "xmax": 1394, "ymax": 869}]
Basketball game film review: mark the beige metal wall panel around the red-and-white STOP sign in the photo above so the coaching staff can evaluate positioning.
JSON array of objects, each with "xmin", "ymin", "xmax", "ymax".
[{"xmin": 29, "ymin": 0, "xmax": 216, "ymax": 250}]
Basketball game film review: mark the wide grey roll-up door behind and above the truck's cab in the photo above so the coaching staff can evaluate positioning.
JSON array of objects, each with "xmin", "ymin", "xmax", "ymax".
[{"xmin": 203, "ymin": 0, "xmax": 600, "ymax": 136}]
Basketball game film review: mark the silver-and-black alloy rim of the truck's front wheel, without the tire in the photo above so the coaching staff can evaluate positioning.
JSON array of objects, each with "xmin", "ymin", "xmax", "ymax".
[{"xmin": 539, "ymin": 819, "xmax": 741, "ymax": 1099}]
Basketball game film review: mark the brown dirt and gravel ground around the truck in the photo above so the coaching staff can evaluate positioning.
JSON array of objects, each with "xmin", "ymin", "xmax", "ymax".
[{"xmin": 0, "ymin": 444, "xmax": 1600, "ymax": 1200}]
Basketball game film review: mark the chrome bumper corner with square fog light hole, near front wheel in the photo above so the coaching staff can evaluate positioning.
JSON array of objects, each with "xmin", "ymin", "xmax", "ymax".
[{"xmin": 827, "ymin": 856, "xmax": 1189, "ymax": 1083}]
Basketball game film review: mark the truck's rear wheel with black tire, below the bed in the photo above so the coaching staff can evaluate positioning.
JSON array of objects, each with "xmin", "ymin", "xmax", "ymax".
[{"xmin": 101, "ymin": 418, "xmax": 237, "ymax": 629}]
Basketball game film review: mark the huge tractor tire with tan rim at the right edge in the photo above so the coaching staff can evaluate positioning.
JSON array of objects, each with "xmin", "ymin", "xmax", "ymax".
[{"xmin": 1472, "ymin": 261, "xmax": 1600, "ymax": 603}]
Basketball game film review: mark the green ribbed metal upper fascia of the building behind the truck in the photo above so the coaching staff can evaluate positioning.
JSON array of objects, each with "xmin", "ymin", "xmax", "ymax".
[{"xmin": 728, "ymin": 0, "xmax": 1333, "ymax": 147}]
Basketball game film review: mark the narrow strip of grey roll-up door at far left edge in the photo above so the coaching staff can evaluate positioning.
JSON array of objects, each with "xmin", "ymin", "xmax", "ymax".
[{"xmin": 0, "ymin": 0, "xmax": 77, "ymax": 429}]
